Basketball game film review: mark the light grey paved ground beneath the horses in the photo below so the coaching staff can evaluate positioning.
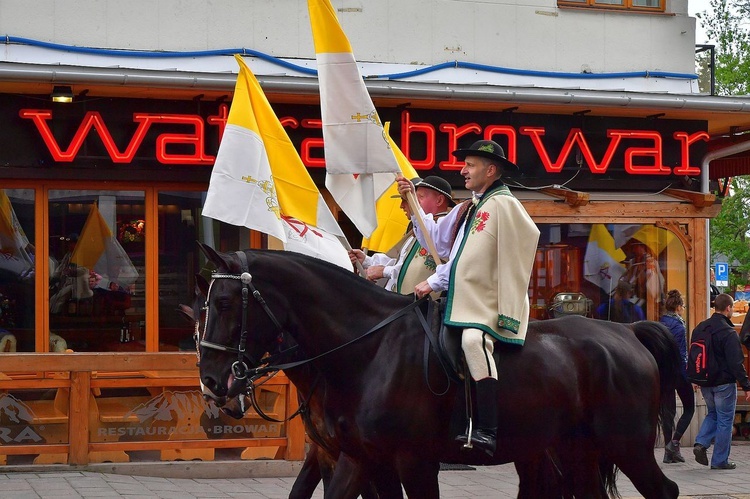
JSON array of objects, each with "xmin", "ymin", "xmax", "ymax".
[{"xmin": 0, "ymin": 441, "xmax": 750, "ymax": 499}]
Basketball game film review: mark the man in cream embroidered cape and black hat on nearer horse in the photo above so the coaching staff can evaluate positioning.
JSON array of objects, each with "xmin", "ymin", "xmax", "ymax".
[{"xmin": 398, "ymin": 140, "xmax": 539, "ymax": 455}]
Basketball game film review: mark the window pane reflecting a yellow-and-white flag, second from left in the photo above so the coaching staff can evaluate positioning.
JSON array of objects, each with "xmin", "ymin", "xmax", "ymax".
[{"xmin": 49, "ymin": 190, "xmax": 147, "ymax": 351}]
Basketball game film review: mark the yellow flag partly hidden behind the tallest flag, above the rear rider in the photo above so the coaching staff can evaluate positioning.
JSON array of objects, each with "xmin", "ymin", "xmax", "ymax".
[{"xmin": 362, "ymin": 121, "xmax": 419, "ymax": 253}]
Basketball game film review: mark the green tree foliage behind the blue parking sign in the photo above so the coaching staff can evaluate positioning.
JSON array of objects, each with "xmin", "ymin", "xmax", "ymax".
[{"xmin": 710, "ymin": 177, "xmax": 750, "ymax": 290}]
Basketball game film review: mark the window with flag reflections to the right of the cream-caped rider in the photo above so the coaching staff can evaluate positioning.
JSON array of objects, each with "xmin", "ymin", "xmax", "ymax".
[{"xmin": 529, "ymin": 224, "xmax": 687, "ymax": 322}]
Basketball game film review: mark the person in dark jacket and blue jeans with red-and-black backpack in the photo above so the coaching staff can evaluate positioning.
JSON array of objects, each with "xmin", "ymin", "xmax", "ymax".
[{"xmin": 687, "ymin": 293, "xmax": 750, "ymax": 470}]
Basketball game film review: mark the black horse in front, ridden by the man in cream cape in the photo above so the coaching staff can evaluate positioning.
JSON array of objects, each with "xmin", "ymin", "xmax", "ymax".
[{"xmin": 199, "ymin": 246, "xmax": 679, "ymax": 499}]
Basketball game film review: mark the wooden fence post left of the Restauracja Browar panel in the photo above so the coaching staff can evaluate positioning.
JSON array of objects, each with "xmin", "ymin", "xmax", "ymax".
[{"xmin": 68, "ymin": 371, "xmax": 91, "ymax": 465}]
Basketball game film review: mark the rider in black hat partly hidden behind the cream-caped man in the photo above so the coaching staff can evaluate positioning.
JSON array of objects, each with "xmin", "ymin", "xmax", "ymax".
[{"xmin": 349, "ymin": 175, "xmax": 454, "ymax": 294}]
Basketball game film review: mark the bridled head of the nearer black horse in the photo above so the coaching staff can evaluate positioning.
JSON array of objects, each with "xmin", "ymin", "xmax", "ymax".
[{"xmin": 193, "ymin": 243, "xmax": 300, "ymax": 407}]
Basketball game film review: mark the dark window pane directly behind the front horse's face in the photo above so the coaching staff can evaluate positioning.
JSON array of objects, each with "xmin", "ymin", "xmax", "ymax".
[{"xmin": 159, "ymin": 191, "xmax": 250, "ymax": 351}]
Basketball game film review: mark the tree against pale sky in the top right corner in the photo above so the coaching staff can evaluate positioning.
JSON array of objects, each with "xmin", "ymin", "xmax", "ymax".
[{"xmin": 696, "ymin": 0, "xmax": 750, "ymax": 95}]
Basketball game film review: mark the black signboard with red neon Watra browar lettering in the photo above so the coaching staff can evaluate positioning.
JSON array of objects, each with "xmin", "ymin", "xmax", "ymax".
[{"xmin": 0, "ymin": 96, "xmax": 709, "ymax": 190}]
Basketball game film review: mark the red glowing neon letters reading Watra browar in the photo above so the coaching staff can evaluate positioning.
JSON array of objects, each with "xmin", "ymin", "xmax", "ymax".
[{"xmin": 19, "ymin": 104, "xmax": 709, "ymax": 176}]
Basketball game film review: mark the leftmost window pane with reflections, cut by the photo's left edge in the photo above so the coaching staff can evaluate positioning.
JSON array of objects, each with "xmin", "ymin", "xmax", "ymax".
[{"xmin": 0, "ymin": 189, "xmax": 36, "ymax": 353}]
